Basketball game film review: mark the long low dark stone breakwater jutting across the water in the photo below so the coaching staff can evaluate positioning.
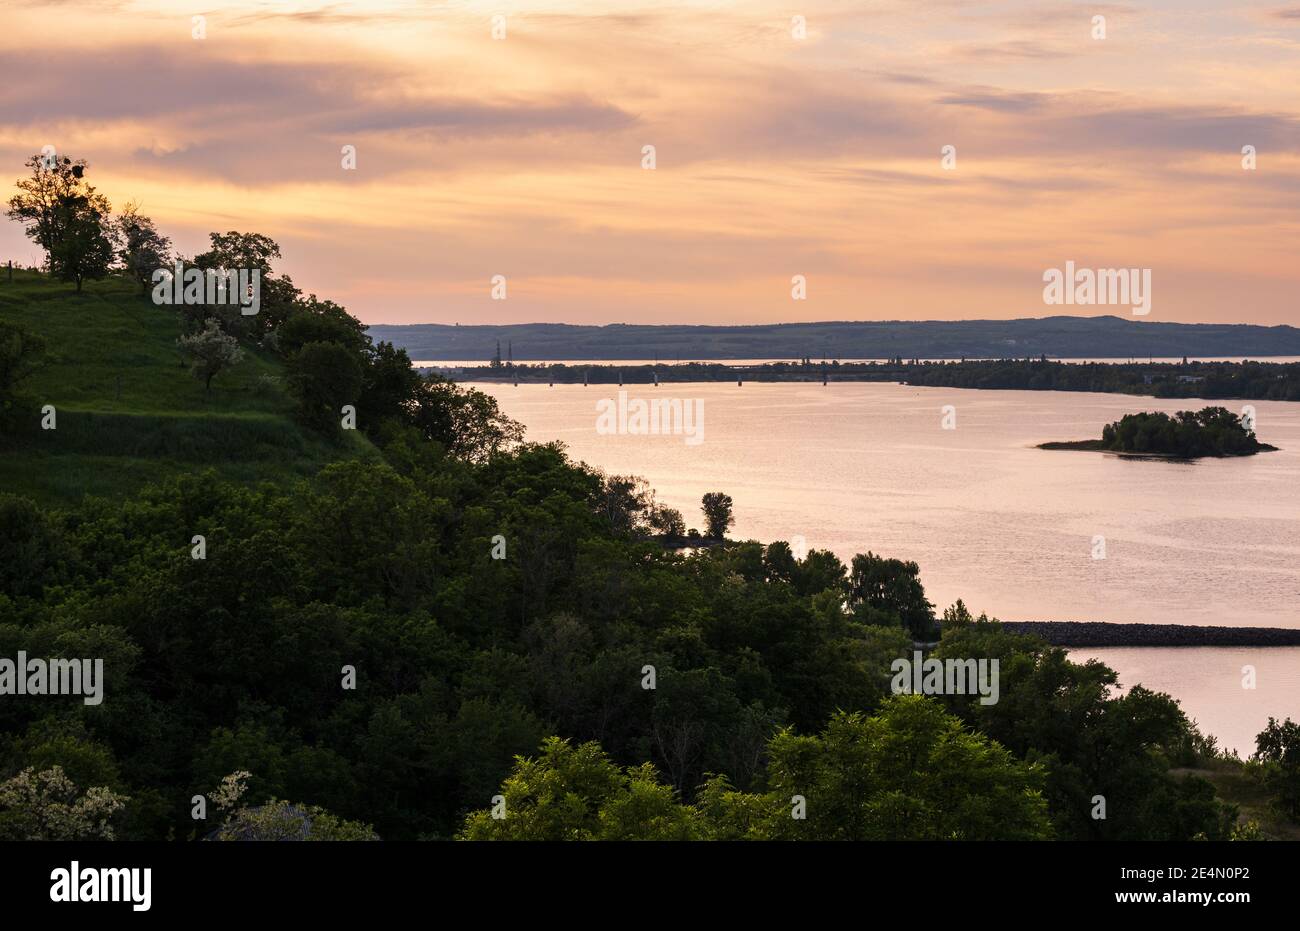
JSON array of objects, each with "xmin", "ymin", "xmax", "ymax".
[{"xmin": 1001, "ymin": 620, "xmax": 1300, "ymax": 648}]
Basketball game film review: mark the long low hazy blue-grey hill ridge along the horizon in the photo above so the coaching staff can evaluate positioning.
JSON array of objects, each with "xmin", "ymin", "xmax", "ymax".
[{"xmin": 369, "ymin": 316, "xmax": 1300, "ymax": 361}]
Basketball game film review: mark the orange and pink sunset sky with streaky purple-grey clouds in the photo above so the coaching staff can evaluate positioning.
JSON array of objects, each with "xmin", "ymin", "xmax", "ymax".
[{"xmin": 0, "ymin": 0, "xmax": 1300, "ymax": 325}]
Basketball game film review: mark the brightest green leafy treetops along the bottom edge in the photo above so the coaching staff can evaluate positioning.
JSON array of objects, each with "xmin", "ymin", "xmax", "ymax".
[{"xmin": 459, "ymin": 696, "xmax": 1052, "ymax": 840}]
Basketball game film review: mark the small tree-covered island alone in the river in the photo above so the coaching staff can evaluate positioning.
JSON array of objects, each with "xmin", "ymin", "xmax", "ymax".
[{"xmin": 1039, "ymin": 407, "xmax": 1278, "ymax": 459}]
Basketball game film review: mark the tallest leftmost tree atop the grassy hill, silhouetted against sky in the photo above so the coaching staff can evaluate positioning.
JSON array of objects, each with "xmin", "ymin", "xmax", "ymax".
[{"xmin": 7, "ymin": 155, "xmax": 113, "ymax": 291}]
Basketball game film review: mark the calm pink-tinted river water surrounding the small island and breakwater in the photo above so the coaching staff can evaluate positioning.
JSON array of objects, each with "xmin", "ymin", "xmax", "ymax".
[{"xmin": 477, "ymin": 382, "xmax": 1300, "ymax": 754}]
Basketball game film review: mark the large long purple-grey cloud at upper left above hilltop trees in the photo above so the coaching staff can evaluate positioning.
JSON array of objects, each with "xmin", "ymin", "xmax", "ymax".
[{"xmin": 0, "ymin": 43, "xmax": 637, "ymax": 183}]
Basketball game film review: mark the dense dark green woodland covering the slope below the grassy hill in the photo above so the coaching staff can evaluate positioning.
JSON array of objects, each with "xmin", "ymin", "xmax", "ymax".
[{"xmin": 0, "ymin": 439, "xmax": 1248, "ymax": 839}]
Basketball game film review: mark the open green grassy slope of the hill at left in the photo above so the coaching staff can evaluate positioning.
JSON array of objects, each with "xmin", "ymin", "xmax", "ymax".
[{"xmin": 0, "ymin": 272, "xmax": 377, "ymax": 503}]
